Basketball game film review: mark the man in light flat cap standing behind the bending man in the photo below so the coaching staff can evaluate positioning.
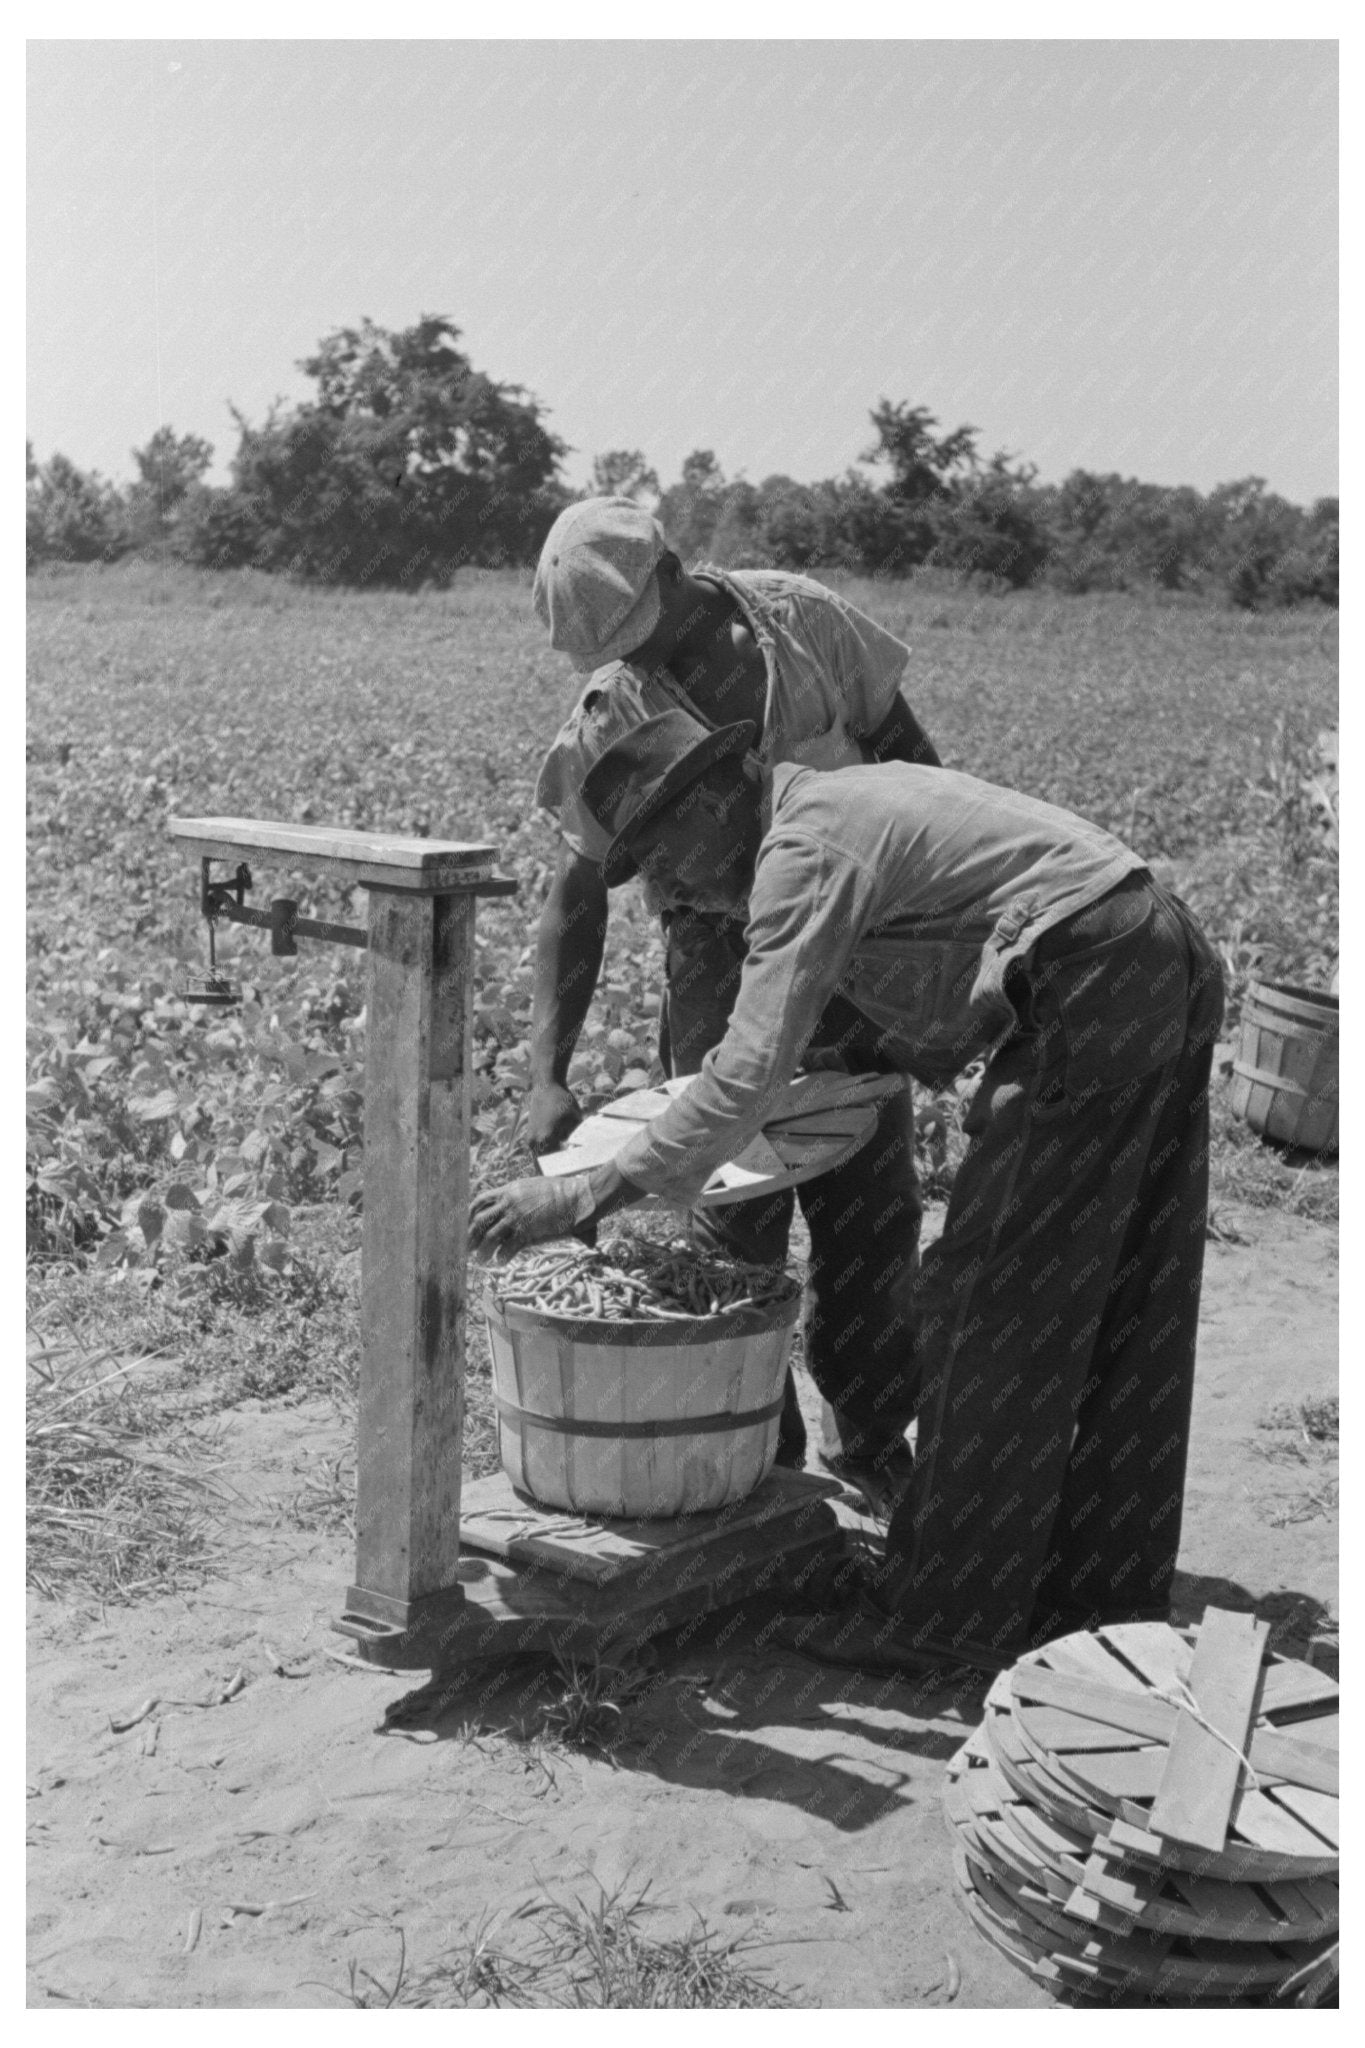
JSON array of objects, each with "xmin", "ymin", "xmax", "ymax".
[{"xmin": 528, "ymin": 498, "xmax": 937, "ymax": 1491}]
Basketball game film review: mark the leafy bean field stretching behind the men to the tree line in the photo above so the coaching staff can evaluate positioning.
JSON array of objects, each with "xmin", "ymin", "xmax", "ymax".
[{"xmin": 27, "ymin": 561, "xmax": 1338, "ymax": 1540}]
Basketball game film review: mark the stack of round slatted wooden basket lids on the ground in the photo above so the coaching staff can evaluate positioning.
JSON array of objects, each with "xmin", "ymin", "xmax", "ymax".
[{"xmin": 945, "ymin": 1608, "xmax": 1338, "ymax": 2005}]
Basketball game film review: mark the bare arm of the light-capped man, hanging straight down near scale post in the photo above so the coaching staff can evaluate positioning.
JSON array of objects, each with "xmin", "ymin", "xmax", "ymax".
[{"xmin": 526, "ymin": 844, "xmax": 608, "ymax": 1153}]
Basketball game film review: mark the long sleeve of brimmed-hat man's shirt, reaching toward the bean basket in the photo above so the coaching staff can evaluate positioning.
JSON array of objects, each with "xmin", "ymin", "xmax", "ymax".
[{"xmin": 616, "ymin": 836, "xmax": 874, "ymax": 1204}]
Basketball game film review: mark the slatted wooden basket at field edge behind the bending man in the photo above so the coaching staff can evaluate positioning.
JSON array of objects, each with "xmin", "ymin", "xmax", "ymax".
[{"xmin": 1232, "ymin": 981, "xmax": 1340, "ymax": 1153}]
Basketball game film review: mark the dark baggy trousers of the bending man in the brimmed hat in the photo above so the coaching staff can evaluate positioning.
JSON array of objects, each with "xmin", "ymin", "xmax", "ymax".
[{"xmin": 878, "ymin": 877, "xmax": 1222, "ymax": 1655}]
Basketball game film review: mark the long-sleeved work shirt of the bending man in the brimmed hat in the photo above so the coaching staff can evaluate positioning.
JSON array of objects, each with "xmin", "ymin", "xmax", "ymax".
[{"xmin": 616, "ymin": 762, "xmax": 1142, "ymax": 1202}]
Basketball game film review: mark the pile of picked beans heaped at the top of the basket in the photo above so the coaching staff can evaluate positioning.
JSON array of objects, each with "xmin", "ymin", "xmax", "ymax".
[{"xmin": 489, "ymin": 1235, "xmax": 800, "ymax": 1323}]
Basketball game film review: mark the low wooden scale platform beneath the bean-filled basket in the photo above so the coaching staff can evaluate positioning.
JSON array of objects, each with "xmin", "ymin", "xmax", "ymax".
[{"xmin": 334, "ymin": 1470, "xmax": 845, "ymax": 1671}]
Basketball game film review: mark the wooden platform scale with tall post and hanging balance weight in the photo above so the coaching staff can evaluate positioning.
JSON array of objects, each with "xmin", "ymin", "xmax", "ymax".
[{"xmin": 170, "ymin": 817, "xmax": 843, "ymax": 1671}]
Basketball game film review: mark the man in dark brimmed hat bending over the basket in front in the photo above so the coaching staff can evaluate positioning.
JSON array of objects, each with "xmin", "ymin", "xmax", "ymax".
[{"xmin": 471, "ymin": 711, "xmax": 1222, "ymax": 1667}]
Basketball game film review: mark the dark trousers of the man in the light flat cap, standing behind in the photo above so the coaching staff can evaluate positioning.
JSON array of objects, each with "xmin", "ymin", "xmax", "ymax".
[{"xmin": 659, "ymin": 911, "xmax": 923, "ymax": 1462}]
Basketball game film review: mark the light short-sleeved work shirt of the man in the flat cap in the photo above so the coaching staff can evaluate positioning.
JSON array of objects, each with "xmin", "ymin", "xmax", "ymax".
[{"xmin": 536, "ymin": 567, "xmax": 911, "ymax": 862}]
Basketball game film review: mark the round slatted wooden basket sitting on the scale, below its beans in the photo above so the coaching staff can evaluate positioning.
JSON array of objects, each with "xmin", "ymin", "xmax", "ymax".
[{"xmin": 483, "ymin": 1280, "xmax": 800, "ymax": 1520}]
